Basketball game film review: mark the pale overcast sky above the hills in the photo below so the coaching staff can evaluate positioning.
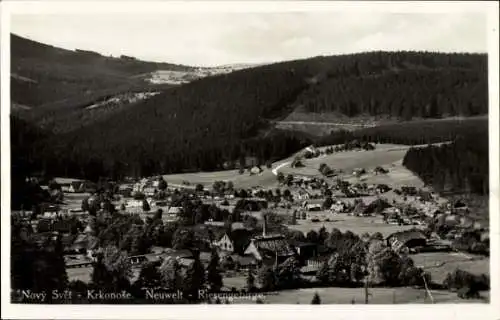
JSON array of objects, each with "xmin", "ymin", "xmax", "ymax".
[{"xmin": 11, "ymin": 12, "xmax": 487, "ymax": 66}]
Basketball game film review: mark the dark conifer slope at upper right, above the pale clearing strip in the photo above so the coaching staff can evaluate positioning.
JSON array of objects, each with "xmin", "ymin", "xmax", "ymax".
[{"xmin": 295, "ymin": 52, "xmax": 488, "ymax": 120}]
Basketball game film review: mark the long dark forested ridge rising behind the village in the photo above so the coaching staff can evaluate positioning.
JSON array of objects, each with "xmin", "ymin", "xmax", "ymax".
[{"xmin": 13, "ymin": 40, "xmax": 488, "ymax": 181}]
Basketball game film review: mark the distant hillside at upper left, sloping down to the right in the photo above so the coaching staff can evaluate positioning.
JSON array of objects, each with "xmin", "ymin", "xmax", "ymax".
[{"xmin": 11, "ymin": 34, "xmax": 189, "ymax": 109}]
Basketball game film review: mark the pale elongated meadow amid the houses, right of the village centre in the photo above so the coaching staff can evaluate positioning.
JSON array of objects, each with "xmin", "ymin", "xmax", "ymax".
[{"xmin": 288, "ymin": 212, "xmax": 419, "ymax": 237}]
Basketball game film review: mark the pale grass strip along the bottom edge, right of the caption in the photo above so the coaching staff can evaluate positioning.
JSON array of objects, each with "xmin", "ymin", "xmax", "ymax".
[{"xmin": 256, "ymin": 288, "xmax": 489, "ymax": 304}]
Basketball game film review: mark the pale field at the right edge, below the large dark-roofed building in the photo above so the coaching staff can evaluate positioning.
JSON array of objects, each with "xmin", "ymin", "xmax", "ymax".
[{"xmin": 411, "ymin": 252, "xmax": 490, "ymax": 283}]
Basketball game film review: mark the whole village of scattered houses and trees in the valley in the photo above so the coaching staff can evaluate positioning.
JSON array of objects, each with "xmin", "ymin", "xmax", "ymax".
[{"xmin": 13, "ymin": 144, "xmax": 489, "ymax": 304}]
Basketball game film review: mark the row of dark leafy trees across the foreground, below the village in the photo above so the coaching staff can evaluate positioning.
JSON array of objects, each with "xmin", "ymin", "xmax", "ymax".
[{"xmin": 11, "ymin": 212, "xmax": 489, "ymax": 304}]
